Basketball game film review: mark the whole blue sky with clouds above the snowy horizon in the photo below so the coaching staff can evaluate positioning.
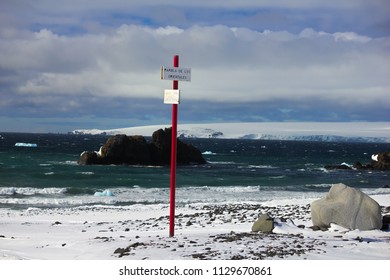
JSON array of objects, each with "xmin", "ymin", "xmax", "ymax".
[{"xmin": 0, "ymin": 0, "xmax": 390, "ymax": 132}]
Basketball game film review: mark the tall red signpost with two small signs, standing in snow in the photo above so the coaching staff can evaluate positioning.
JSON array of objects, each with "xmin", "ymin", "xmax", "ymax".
[{"xmin": 161, "ymin": 55, "xmax": 191, "ymax": 237}]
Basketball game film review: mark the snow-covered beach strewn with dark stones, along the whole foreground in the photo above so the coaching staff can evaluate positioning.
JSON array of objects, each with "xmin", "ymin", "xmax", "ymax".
[{"xmin": 0, "ymin": 200, "xmax": 390, "ymax": 260}]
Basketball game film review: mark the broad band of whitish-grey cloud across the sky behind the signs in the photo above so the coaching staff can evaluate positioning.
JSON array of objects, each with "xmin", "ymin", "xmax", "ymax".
[{"xmin": 0, "ymin": 25, "xmax": 390, "ymax": 106}]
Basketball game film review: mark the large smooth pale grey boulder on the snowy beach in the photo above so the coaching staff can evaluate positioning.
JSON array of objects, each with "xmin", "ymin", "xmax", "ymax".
[{"xmin": 311, "ymin": 184, "xmax": 382, "ymax": 230}]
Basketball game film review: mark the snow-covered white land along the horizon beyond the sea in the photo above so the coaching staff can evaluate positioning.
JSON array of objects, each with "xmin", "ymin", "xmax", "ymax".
[{"xmin": 72, "ymin": 122, "xmax": 390, "ymax": 143}]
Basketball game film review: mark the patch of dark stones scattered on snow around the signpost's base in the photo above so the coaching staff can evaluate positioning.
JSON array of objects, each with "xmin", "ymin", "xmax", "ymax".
[{"xmin": 114, "ymin": 204, "xmax": 318, "ymax": 260}]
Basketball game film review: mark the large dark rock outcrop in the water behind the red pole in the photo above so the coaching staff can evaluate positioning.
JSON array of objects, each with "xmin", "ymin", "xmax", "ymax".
[{"xmin": 79, "ymin": 128, "xmax": 206, "ymax": 165}]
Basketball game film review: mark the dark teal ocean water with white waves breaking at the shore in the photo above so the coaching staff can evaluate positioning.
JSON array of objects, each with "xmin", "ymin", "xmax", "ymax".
[{"xmin": 0, "ymin": 133, "xmax": 390, "ymax": 209}]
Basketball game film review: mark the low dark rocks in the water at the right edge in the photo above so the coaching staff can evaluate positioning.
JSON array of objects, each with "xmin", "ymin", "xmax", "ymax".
[{"xmin": 325, "ymin": 152, "xmax": 390, "ymax": 170}]
